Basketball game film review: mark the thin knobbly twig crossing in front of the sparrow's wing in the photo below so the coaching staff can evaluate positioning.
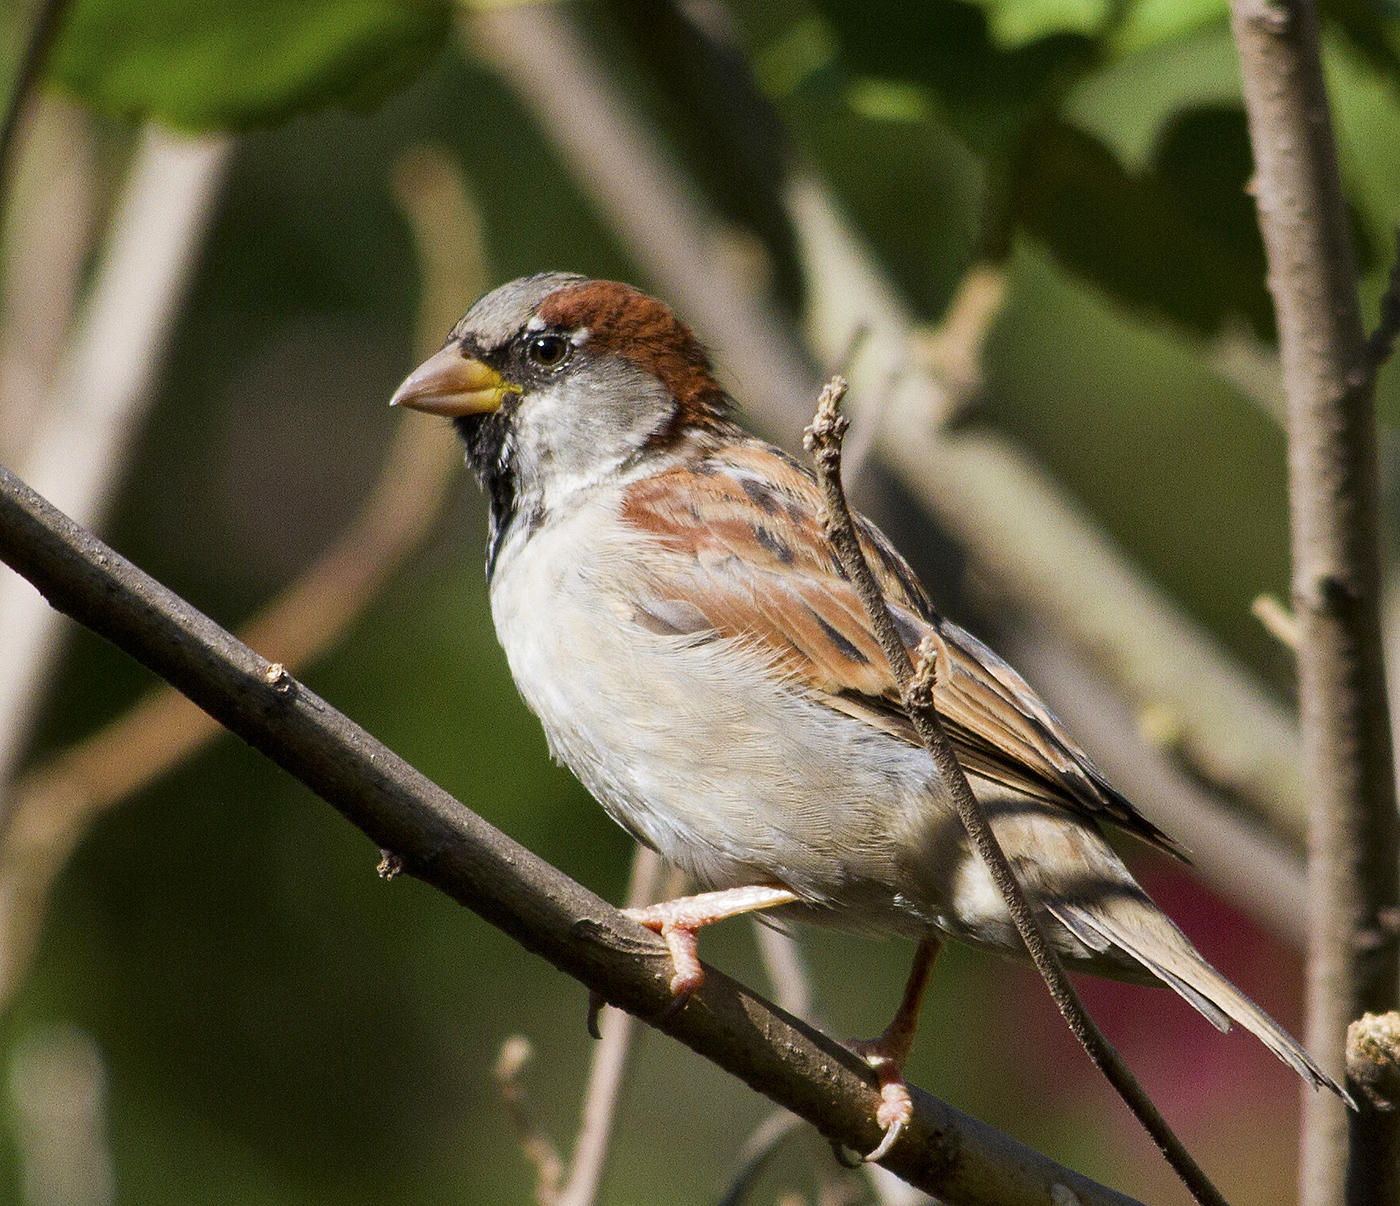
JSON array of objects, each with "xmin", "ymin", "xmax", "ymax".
[{"xmin": 806, "ymin": 377, "xmax": 1225, "ymax": 1206}]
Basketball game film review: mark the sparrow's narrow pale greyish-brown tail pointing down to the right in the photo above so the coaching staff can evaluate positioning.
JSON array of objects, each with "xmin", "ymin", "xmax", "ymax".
[{"xmin": 1043, "ymin": 894, "xmax": 1355, "ymax": 1108}]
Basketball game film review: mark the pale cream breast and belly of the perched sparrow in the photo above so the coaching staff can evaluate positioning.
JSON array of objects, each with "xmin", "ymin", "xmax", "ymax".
[{"xmin": 491, "ymin": 493, "xmax": 952, "ymax": 929}]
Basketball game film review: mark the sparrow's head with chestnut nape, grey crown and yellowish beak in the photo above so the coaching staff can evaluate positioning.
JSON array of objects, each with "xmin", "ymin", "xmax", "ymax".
[{"xmin": 391, "ymin": 272, "xmax": 729, "ymax": 518}]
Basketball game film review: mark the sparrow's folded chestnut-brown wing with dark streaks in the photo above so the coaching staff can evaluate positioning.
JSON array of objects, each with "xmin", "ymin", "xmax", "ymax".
[{"xmin": 623, "ymin": 441, "xmax": 1182, "ymax": 856}]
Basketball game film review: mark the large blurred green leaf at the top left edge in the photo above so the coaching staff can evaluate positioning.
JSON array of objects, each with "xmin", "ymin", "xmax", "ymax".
[{"xmin": 53, "ymin": 0, "xmax": 452, "ymax": 129}]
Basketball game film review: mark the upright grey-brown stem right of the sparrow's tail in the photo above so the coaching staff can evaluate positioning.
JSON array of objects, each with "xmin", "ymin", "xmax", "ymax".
[{"xmin": 1231, "ymin": 0, "xmax": 1400, "ymax": 1206}]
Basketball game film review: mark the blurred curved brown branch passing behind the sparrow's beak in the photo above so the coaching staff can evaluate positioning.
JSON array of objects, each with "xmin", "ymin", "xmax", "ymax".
[{"xmin": 0, "ymin": 143, "xmax": 486, "ymax": 1004}]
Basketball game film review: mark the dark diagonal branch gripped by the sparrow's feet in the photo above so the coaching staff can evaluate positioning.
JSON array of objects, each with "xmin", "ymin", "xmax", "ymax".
[{"xmin": 0, "ymin": 466, "xmax": 1130, "ymax": 1206}]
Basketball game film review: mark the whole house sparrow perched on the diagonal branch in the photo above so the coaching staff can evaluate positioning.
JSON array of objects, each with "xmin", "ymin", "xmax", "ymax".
[{"xmin": 393, "ymin": 273, "xmax": 1341, "ymax": 1156}]
